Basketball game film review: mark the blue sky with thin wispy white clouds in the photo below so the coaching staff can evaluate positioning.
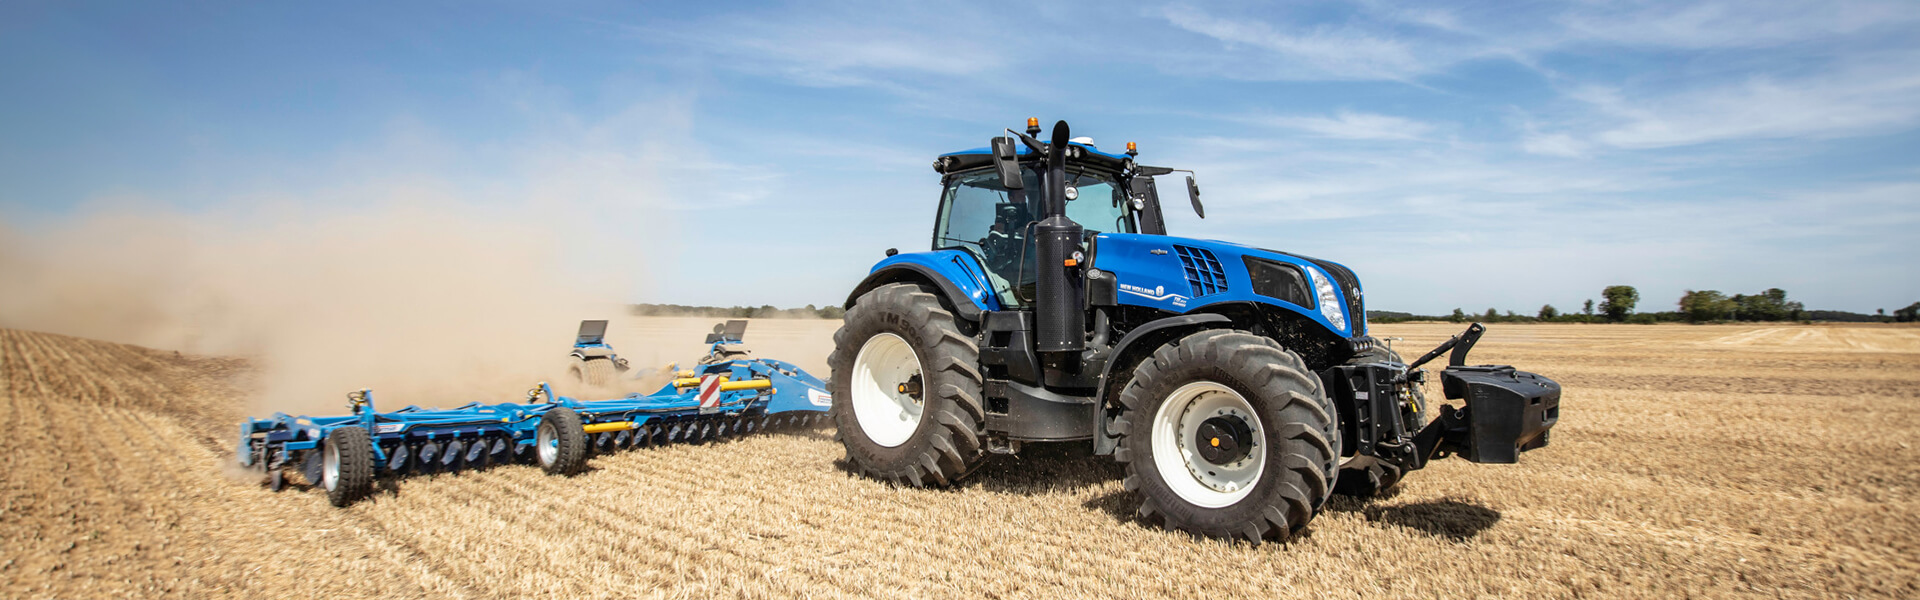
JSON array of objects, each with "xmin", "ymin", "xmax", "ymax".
[{"xmin": 0, "ymin": 2, "xmax": 1920, "ymax": 313}]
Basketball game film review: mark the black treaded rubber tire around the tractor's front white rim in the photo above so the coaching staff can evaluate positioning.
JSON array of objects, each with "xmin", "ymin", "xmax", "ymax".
[{"xmin": 1114, "ymin": 329, "xmax": 1340, "ymax": 544}]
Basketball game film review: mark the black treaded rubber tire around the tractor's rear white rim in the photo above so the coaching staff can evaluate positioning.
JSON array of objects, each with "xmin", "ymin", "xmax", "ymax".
[{"xmin": 828, "ymin": 283, "xmax": 987, "ymax": 487}]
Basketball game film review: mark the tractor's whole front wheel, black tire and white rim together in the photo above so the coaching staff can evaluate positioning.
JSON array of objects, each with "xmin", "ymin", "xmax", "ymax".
[{"xmin": 1114, "ymin": 329, "xmax": 1340, "ymax": 544}]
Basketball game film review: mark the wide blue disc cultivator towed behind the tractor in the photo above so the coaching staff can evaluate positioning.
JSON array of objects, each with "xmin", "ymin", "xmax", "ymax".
[{"xmin": 236, "ymin": 321, "xmax": 831, "ymax": 506}]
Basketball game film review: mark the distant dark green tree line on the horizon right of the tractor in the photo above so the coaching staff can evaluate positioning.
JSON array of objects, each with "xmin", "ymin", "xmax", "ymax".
[{"xmin": 1367, "ymin": 285, "xmax": 1920, "ymax": 323}]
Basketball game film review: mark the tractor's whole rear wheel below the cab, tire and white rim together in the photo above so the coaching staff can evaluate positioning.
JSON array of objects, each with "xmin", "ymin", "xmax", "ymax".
[{"xmin": 828, "ymin": 283, "xmax": 987, "ymax": 487}]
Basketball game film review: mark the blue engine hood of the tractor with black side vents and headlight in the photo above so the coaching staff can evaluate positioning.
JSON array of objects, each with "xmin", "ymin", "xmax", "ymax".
[{"xmin": 1094, "ymin": 233, "xmax": 1367, "ymax": 337}]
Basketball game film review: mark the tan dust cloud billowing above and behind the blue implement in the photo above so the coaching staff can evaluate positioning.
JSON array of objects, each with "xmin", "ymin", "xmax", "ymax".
[{"xmin": 0, "ymin": 200, "xmax": 632, "ymax": 413}]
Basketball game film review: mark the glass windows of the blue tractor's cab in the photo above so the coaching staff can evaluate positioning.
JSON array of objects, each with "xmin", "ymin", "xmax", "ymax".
[{"xmin": 933, "ymin": 167, "xmax": 1135, "ymax": 308}]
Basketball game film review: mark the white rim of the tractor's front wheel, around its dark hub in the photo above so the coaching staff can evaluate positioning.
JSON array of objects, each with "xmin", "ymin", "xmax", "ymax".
[{"xmin": 1152, "ymin": 381, "xmax": 1267, "ymax": 508}]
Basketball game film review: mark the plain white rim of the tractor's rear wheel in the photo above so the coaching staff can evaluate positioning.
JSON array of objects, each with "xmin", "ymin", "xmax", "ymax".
[{"xmin": 849, "ymin": 333, "xmax": 927, "ymax": 448}]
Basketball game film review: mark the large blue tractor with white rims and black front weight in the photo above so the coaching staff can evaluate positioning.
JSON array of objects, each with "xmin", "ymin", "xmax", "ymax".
[{"xmin": 828, "ymin": 119, "xmax": 1559, "ymax": 542}]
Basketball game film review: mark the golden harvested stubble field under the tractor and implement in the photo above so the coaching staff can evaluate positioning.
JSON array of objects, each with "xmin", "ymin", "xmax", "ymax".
[{"xmin": 0, "ymin": 319, "xmax": 1920, "ymax": 598}]
